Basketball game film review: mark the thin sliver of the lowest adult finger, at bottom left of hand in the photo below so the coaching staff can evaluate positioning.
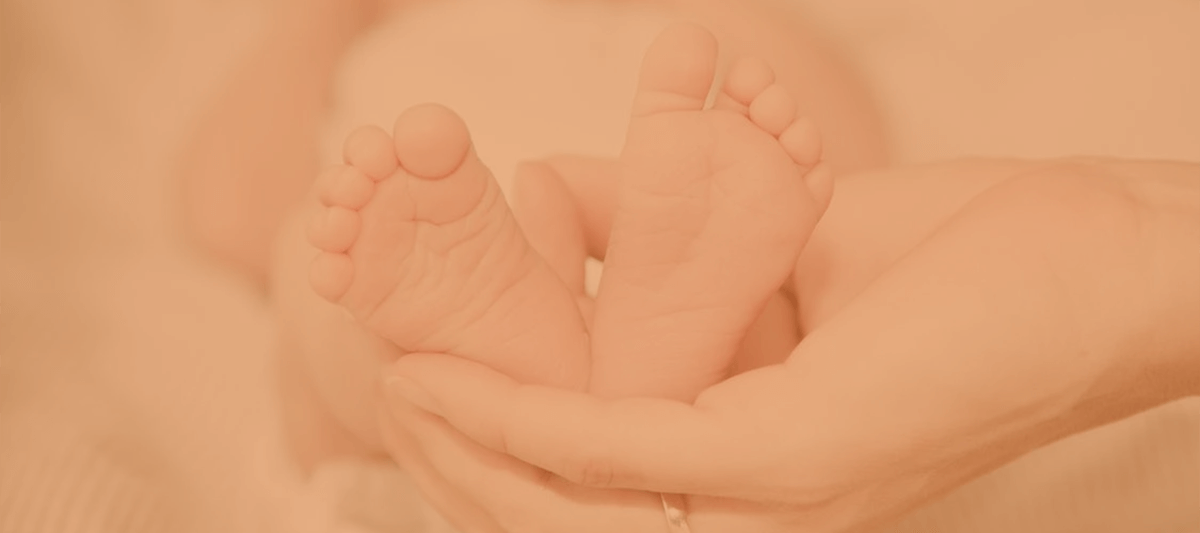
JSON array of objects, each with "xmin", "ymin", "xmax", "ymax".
[{"xmin": 379, "ymin": 405, "xmax": 504, "ymax": 533}]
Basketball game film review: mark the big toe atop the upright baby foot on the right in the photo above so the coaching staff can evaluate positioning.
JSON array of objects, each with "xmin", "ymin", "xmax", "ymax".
[{"xmin": 634, "ymin": 23, "xmax": 716, "ymax": 116}]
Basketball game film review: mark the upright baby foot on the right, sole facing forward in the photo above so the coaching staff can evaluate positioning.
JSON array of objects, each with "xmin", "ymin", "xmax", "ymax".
[{"xmin": 592, "ymin": 25, "xmax": 832, "ymax": 401}]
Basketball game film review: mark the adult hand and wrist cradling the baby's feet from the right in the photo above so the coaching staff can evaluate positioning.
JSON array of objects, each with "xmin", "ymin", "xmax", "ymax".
[{"xmin": 384, "ymin": 156, "xmax": 1200, "ymax": 533}]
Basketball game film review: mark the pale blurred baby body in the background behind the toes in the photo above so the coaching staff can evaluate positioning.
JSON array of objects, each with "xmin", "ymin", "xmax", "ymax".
[{"xmin": 323, "ymin": 0, "xmax": 883, "ymax": 192}]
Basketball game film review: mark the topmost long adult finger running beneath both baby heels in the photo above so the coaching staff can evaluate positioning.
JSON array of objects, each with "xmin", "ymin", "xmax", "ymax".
[{"xmin": 388, "ymin": 354, "xmax": 791, "ymax": 496}]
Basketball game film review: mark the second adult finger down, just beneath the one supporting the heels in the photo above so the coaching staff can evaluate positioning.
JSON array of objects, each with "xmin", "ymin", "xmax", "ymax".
[{"xmin": 393, "ymin": 384, "xmax": 664, "ymax": 533}]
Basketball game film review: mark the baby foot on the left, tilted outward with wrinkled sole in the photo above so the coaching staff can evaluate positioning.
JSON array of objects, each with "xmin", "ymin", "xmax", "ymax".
[{"xmin": 308, "ymin": 104, "xmax": 588, "ymax": 388}]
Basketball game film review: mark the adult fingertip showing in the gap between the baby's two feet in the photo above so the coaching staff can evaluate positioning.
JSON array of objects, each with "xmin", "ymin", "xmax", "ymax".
[{"xmin": 512, "ymin": 163, "xmax": 588, "ymax": 295}]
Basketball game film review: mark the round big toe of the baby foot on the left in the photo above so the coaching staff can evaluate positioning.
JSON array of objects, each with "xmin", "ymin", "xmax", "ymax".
[{"xmin": 392, "ymin": 103, "xmax": 470, "ymax": 180}]
